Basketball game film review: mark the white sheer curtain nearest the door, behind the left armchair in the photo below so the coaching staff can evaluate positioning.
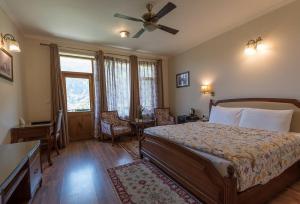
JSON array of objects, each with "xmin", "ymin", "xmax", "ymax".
[{"xmin": 104, "ymin": 56, "xmax": 130, "ymax": 118}]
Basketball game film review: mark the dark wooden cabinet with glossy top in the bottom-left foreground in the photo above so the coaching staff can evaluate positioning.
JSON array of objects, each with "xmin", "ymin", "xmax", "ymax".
[{"xmin": 0, "ymin": 141, "xmax": 42, "ymax": 204}]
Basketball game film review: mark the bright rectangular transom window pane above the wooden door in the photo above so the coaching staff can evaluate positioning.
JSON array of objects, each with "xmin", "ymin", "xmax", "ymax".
[{"xmin": 60, "ymin": 56, "xmax": 93, "ymax": 73}]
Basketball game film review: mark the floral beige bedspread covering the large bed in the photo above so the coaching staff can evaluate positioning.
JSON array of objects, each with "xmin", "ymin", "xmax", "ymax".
[{"xmin": 145, "ymin": 122, "xmax": 300, "ymax": 192}]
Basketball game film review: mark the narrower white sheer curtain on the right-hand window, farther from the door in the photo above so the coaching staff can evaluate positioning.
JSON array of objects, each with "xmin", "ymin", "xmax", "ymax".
[{"xmin": 138, "ymin": 61, "xmax": 158, "ymax": 117}]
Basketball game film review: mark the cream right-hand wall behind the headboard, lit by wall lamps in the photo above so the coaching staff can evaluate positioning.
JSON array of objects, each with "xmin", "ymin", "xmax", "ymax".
[{"xmin": 169, "ymin": 1, "xmax": 300, "ymax": 114}]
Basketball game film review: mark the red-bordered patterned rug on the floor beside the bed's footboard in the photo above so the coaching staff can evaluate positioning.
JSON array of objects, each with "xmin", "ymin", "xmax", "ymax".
[{"xmin": 107, "ymin": 161, "xmax": 201, "ymax": 204}]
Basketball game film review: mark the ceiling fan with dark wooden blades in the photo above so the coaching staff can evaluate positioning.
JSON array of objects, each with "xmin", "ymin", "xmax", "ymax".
[{"xmin": 114, "ymin": 2, "xmax": 179, "ymax": 38}]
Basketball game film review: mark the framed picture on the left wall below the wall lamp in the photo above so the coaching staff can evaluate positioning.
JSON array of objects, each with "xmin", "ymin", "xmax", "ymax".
[{"xmin": 0, "ymin": 48, "xmax": 14, "ymax": 81}]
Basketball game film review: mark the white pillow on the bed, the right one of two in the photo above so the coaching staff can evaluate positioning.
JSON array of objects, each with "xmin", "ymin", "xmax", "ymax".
[{"xmin": 239, "ymin": 108, "xmax": 294, "ymax": 132}]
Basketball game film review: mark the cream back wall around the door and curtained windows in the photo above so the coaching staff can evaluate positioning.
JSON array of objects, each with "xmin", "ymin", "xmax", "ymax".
[{"xmin": 24, "ymin": 36, "xmax": 169, "ymax": 121}]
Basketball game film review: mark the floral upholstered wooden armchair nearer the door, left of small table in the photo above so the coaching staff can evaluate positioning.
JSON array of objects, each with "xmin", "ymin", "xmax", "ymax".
[{"xmin": 101, "ymin": 111, "xmax": 132, "ymax": 145}]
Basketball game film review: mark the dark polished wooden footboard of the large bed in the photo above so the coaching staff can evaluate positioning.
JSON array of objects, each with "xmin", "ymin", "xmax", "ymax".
[{"xmin": 140, "ymin": 134, "xmax": 237, "ymax": 204}]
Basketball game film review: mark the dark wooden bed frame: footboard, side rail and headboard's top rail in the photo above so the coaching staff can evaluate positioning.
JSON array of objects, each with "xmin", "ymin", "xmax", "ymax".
[{"xmin": 140, "ymin": 98, "xmax": 300, "ymax": 204}]
